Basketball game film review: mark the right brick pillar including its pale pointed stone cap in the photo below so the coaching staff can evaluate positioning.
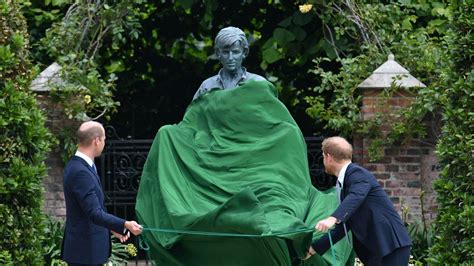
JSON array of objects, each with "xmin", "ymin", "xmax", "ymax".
[{"xmin": 353, "ymin": 55, "xmax": 439, "ymax": 223}]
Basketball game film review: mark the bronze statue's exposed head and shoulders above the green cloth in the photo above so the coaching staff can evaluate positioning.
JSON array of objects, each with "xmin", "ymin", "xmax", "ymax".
[{"xmin": 193, "ymin": 27, "xmax": 266, "ymax": 100}]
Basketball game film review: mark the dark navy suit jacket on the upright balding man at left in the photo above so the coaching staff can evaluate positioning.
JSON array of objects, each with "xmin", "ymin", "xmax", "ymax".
[{"xmin": 61, "ymin": 156, "xmax": 125, "ymax": 264}]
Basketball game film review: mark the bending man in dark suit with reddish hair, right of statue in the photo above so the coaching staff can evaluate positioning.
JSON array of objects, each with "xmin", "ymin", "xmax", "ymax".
[{"xmin": 308, "ymin": 137, "xmax": 411, "ymax": 266}]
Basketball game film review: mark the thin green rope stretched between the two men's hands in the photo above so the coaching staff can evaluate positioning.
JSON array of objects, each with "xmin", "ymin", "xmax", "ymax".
[{"xmin": 138, "ymin": 227, "xmax": 337, "ymax": 265}]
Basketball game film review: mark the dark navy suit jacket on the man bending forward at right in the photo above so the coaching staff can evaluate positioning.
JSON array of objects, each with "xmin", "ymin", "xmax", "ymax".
[{"xmin": 312, "ymin": 163, "xmax": 411, "ymax": 263}]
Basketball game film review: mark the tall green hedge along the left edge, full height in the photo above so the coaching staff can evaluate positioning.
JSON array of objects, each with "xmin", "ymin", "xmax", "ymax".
[{"xmin": 0, "ymin": 0, "xmax": 51, "ymax": 265}]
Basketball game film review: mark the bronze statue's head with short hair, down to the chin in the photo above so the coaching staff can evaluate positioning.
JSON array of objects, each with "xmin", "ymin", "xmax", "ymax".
[{"xmin": 214, "ymin": 27, "xmax": 249, "ymax": 71}]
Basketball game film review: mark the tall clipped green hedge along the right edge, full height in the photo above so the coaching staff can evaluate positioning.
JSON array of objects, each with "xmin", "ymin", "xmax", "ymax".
[{"xmin": 429, "ymin": 1, "xmax": 474, "ymax": 258}]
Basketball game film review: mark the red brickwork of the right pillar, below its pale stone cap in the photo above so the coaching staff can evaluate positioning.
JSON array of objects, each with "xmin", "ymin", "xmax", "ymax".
[{"xmin": 353, "ymin": 89, "xmax": 438, "ymax": 223}]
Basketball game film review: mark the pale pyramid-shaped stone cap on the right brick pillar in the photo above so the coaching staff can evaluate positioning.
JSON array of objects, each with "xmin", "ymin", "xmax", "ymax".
[{"xmin": 357, "ymin": 54, "xmax": 426, "ymax": 89}]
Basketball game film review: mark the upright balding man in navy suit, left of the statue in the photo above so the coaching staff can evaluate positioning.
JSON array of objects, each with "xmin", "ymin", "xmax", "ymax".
[{"xmin": 61, "ymin": 121, "xmax": 142, "ymax": 265}]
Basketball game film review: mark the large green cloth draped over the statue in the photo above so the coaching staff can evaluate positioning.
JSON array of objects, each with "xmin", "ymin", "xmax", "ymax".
[{"xmin": 136, "ymin": 81, "xmax": 351, "ymax": 265}]
